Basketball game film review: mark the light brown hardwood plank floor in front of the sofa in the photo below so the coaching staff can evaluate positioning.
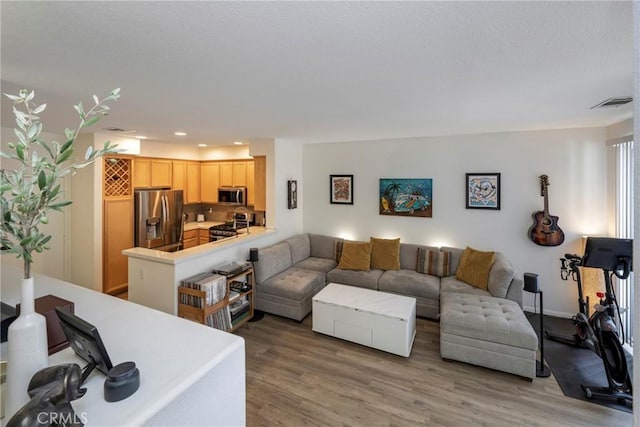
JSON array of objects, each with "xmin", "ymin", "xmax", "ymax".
[{"xmin": 236, "ymin": 314, "xmax": 633, "ymax": 426}]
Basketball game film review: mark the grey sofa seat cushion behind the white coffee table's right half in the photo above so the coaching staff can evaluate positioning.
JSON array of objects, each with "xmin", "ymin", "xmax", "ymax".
[{"xmin": 378, "ymin": 270, "xmax": 440, "ymax": 301}]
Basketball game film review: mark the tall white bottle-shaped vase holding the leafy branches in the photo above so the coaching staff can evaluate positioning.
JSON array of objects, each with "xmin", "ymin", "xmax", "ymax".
[{"xmin": 5, "ymin": 277, "xmax": 49, "ymax": 420}]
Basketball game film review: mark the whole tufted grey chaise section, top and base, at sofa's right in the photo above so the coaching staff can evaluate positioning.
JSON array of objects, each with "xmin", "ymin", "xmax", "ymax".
[{"xmin": 440, "ymin": 292, "xmax": 538, "ymax": 380}]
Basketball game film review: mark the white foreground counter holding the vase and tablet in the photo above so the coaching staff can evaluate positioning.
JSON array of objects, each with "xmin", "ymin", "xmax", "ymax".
[{"xmin": 2, "ymin": 264, "xmax": 246, "ymax": 427}]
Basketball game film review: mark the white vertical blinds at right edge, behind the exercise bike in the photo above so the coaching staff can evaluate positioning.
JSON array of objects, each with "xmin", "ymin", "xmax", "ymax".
[{"xmin": 612, "ymin": 141, "xmax": 634, "ymax": 347}]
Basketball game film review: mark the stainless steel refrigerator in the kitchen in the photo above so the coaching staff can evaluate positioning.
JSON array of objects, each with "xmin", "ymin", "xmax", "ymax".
[{"xmin": 134, "ymin": 189, "xmax": 183, "ymax": 252}]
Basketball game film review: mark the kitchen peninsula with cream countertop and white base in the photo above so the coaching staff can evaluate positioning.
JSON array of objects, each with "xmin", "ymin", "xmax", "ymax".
[{"xmin": 122, "ymin": 226, "xmax": 274, "ymax": 315}]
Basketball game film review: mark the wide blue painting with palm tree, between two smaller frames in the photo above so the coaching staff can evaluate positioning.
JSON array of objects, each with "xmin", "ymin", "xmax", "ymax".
[{"xmin": 379, "ymin": 178, "xmax": 433, "ymax": 218}]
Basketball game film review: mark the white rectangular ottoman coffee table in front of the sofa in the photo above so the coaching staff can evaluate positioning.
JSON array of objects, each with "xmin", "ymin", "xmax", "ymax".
[{"xmin": 312, "ymin": 283, "xmax": 416, "ymax": 357}]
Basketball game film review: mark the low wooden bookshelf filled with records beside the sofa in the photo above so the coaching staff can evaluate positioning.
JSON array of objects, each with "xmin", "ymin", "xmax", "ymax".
[{"xmin": 178, "ymin": 268, "xmax": 255, "ymax": 332}]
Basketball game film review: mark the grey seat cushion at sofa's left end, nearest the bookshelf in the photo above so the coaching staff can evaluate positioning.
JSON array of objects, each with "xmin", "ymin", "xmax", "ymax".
[{"xmin": 258, "ymin": 268, "xmax": 325, "ymax": 301}]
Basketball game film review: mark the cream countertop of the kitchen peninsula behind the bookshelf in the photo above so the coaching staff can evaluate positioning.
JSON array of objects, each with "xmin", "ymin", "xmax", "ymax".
[{"xmin": 122, "ymin": 226, "xmax": 274, "ymax": 264}]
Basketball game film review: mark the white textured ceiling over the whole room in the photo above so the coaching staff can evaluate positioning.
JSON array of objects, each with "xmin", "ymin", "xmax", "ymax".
[{"xmin": 0, "ymin": 1, "xmax": 633, "ymax": 144}]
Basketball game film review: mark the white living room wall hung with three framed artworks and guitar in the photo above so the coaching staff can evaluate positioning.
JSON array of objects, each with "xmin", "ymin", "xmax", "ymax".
[{"xmin": 302, "ymin": 128, "xmax": 607, "ymax": 316}]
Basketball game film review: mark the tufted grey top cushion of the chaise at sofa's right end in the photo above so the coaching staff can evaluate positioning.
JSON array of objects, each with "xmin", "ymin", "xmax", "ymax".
[{"xmin": 440, "ymin": 293, "xmax": 538, "ymax": 352}]
